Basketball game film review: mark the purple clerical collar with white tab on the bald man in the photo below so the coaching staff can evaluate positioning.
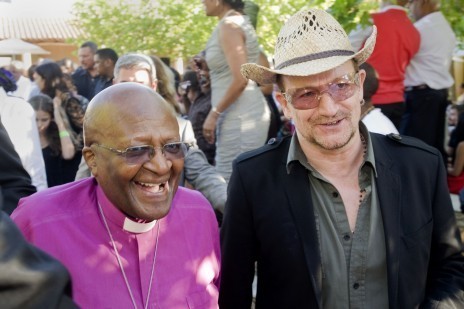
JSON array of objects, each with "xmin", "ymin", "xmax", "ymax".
[{"xmin": 97, "ymin": 186, "xmax": 156, "ymax": 234}]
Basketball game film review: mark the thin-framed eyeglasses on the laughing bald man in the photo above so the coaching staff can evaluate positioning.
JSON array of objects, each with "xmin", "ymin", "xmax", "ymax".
[{"xmin": 93, "ymin": 142, "xmax": 190, "ymax": 165}]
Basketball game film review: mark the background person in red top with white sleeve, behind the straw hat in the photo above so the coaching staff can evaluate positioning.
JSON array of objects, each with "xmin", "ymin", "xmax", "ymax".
[{"xmin": 349, "ymin": 0, "xmax": 420, "ymax": 129}]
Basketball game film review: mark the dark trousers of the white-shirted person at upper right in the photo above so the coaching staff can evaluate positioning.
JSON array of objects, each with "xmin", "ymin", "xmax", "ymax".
[{"xmin": 400, "ymin": 87, "xmax": 448, "ymax": 157}]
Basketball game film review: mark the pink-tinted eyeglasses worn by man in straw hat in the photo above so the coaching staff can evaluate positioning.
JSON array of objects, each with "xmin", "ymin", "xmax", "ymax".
[{"xmin": 282, "ymin": 72, "xmax": 359, "ymax": 109}]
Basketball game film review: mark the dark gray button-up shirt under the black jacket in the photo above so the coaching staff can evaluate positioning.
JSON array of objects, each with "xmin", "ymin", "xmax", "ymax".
[{"xmin": 287, "ymin": 124, "xmax": 388, "ymax": 309}]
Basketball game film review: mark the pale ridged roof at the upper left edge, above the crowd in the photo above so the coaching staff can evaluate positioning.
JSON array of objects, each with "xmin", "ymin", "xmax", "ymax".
[{"xmin": 0, "ymin": 17, "xmax": 81, "ymax": 43}]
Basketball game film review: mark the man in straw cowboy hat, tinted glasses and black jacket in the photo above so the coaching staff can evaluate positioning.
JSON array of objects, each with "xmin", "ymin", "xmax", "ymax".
[{"xmin": 219, "ymin": 9, "xmax": 464, "ymax": 309}]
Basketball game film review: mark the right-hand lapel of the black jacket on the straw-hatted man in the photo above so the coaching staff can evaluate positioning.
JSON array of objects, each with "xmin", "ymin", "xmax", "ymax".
[{"xmin": 371, "ymin": 134, "xmax": 401, "ymax": 308}]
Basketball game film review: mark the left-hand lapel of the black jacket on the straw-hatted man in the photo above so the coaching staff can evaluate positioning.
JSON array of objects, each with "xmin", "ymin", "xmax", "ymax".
[{"xmin": 284, "ymin": 162, "xmax": 322, "ymax": 308}]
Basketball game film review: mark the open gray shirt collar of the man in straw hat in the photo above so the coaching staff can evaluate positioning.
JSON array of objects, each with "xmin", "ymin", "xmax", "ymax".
[{"xmin": 287, "ymin": 121, "xmax": 377, "ymax": 177}]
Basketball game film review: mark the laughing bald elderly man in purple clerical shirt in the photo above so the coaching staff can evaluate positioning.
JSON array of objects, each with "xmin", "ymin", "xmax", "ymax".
[{"xmin": 12, "ymin": 83, "xmax": 220, "ymax": 308}]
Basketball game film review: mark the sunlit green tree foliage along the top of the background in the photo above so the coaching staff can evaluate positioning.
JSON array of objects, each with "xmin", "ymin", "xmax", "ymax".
[{"xmin": 70, "ymin": 0, "xmax": 464, "ymax": 59}]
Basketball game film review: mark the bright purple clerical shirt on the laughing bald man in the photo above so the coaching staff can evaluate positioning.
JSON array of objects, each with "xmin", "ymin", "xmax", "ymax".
[{"xmin": 11, "ymin": 178, "xmax": 220, "ymax": 309}]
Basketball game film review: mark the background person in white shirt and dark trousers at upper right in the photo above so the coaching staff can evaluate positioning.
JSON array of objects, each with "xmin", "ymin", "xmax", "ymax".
[{"xmin": 400, "ymin": 0, "xmax": 456, "ymax": 157}]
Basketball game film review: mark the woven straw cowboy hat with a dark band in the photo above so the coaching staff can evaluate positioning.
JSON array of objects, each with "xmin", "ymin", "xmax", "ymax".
[{"xmin": 241, "ymin": 9, "xmax": 377, "ymax": 85}]
